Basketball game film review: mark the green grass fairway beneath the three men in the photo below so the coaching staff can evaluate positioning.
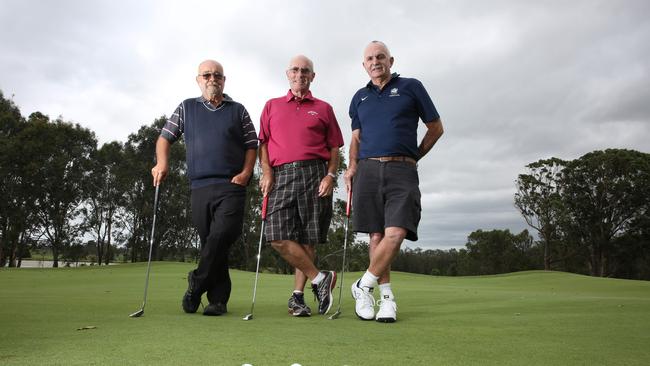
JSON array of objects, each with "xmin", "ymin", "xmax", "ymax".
[{"xmin": 0, "ymin": 263, "xmax": 650, "ymax": 366}]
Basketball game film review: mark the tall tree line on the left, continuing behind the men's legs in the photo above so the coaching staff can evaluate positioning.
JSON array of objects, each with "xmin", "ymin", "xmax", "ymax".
[{"xmin": 0, "ymin": 92, "xmax": 354, "ymax": 273}]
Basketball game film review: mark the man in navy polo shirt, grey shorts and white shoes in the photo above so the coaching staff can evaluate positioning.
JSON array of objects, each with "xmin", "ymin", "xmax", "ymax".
[{"xmin": 345, "ymin": 41, "xmax": 443, "ymax": 323}]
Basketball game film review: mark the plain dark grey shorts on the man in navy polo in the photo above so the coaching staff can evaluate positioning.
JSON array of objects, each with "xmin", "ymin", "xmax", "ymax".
[{"xmin": 352, "ymin": 159, "xmax": 422, "ymax": 241}]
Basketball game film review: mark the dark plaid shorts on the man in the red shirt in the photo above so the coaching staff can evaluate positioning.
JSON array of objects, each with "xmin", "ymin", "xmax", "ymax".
[{"xmin": 264, "ymin": 160, "xmax": 332, "ymax": 245}]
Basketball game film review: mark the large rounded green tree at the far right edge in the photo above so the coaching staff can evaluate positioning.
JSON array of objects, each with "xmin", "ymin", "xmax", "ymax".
[{"xmin": 562, "ymin": 149, "xmax": 650, "ymax": 276}]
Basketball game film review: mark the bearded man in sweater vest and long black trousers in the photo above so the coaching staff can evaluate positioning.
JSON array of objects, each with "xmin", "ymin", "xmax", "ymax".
[{"xmin": 151, "ymin": 60, "xmax": 257, "ymax": 315}]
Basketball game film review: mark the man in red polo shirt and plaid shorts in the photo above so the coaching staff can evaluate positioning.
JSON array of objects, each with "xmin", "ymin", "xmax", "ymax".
[{"xmin": 259, "ymin": 55, "xmax": 343, "ymax": 316}]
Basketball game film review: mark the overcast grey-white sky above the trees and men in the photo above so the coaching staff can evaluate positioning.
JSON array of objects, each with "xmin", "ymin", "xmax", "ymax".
[{"xmin": 0, "ymin": 0, "xmax": 650, "ymax": 249}]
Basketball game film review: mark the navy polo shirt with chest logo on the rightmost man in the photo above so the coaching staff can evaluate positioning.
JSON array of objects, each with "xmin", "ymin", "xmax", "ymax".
[{"xmin": 350, "ymin": 74, "xmax": 440, "ymax": 160}]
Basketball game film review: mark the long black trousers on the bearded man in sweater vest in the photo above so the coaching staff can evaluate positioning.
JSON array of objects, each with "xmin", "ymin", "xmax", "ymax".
[{"xmin": 191, "ymin": 183, "xmax": 246, "ymax": 304}]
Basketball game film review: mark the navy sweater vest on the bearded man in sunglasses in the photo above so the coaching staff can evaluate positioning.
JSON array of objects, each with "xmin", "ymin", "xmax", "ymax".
[{"xmin": 183, "ymin": 98, "xmax": 246, "ymax": 188}]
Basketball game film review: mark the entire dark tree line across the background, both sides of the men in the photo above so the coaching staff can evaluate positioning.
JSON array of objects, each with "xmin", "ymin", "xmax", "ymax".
[{"xmin": 0, "ymin": 91, "xmax": 650, "ymax": 279}]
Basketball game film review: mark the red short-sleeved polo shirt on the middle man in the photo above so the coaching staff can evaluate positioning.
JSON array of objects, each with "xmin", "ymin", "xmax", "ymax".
[{"xmin": 259, "ymin": 90, "xmax": 343, "ymax": 166}]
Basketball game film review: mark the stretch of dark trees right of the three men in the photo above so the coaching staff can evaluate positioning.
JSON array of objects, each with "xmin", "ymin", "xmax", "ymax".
[{"xmin": 393, "ymin": 149, "xmax": 650, "ymax": 280}]
